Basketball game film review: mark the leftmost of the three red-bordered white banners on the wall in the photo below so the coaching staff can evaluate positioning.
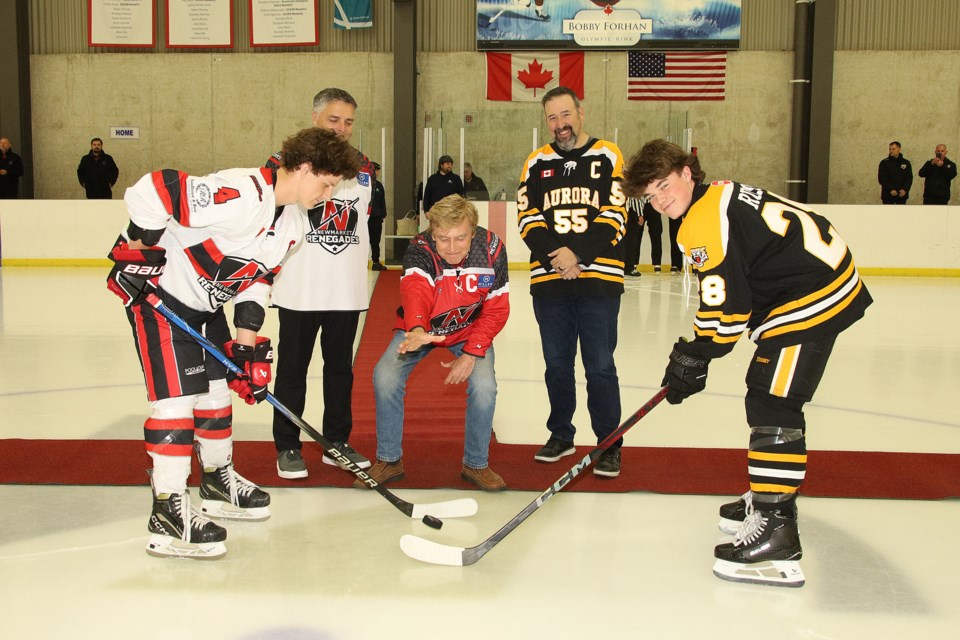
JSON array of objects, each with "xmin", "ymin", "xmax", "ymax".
[{"xmin": 87, "ymin": 0, "xmax": 157, "ymax": 48}]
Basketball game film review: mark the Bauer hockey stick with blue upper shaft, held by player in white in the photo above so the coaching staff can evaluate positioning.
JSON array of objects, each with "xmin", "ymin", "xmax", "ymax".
[{"xmin": 147, "ymin": 293, "xmax": 477, "ymax": 529}]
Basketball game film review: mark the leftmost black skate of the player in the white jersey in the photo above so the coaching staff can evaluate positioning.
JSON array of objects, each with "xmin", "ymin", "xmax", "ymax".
[{"xmin": 147, "ymin": 493, "xmax": 227, "ymax": 560}]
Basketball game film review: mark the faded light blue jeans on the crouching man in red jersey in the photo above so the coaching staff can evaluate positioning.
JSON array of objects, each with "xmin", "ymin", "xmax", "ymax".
[{"xmin": 373, "ymin": 331, "xmax": 497, "ymax": 469}]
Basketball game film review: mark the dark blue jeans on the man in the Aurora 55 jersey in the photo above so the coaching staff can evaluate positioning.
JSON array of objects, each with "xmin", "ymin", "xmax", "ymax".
[{"xmin": 533, "ymin": 296, "xmax": 623, "ymax": 446}]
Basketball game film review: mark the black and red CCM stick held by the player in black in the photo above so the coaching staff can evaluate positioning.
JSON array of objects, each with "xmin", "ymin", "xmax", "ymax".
[{"xmin": 400, "ymin": 387, "xmax": 667, "ymax": 567}]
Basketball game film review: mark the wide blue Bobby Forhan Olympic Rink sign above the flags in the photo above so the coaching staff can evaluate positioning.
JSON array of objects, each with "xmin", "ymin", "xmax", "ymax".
[{"xmin": 477, "ymin": 0, "xmax": 741, "ymax": 51}]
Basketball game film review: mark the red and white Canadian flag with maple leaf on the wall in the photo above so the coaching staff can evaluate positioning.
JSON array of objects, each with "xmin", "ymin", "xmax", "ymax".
[{"xmin": 487, "ymin": 51, "xmax": 583, "ymax": 102}]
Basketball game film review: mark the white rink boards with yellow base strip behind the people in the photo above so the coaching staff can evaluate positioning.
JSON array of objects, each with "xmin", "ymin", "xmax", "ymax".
[{"xmin": 0, "ymin": 200, "xmax": 960, "ymax": 276}]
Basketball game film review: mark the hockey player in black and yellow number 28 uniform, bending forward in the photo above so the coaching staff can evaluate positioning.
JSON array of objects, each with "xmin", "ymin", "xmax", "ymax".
[{"xmin": 623, "ymin": 140, "xmax": 872, "ymax": 587}]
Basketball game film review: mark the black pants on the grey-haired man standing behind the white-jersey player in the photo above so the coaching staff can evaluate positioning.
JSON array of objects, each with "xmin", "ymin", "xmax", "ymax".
[{"xmin": 273, "ymin": 308, "xmax": 360, "ymax": 451}]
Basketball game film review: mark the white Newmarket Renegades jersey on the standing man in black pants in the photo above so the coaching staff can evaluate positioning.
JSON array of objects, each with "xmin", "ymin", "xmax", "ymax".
[{"xmin": 267, "ymin": 152, "xmax": 376, "ymax": 311}]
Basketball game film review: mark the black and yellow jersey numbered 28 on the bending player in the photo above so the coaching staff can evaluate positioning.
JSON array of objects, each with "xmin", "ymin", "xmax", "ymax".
[{"xmin": 677, "ymin": 182, "xmax": 873, "ymax": 358}]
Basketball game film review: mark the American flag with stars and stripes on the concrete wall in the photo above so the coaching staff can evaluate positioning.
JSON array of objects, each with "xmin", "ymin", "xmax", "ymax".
[{"xmin": 627, "ymin": 51, "xmax": 727, "ymax": 100}]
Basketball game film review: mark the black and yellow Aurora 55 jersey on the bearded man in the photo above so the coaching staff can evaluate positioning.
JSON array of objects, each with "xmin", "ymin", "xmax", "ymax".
[{"xmin": 517, "ymin": 138, "xmax": 626, "ymax": 298}]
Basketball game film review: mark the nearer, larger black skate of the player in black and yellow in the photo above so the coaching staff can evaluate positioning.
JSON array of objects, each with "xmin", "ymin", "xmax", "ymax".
[{"xmin": 713, "ymin": 506, "xmax": 805, "ymax": 587}]
